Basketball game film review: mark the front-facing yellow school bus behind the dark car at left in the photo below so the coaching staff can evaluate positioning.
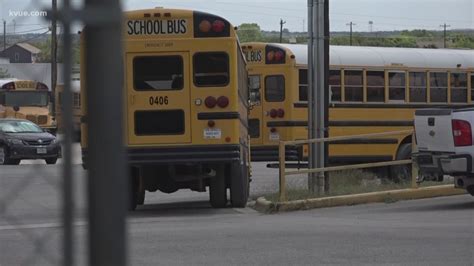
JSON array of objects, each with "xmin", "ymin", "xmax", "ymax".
[{"xmin": 0, "ymin": 79, "xmax": 56, "ymax": 134}]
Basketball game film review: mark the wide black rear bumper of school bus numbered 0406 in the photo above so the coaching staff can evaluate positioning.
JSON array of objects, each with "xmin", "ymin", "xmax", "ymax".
[{"xmin": 82, "ymin": 145, "xmax": 241, "ymax": 166}]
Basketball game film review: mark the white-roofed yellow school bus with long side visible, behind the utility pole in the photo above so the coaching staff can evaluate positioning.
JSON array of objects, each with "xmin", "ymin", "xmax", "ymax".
[{"xmin": 242, "ymin": 43, "xmax": 474, "ymax": 180}]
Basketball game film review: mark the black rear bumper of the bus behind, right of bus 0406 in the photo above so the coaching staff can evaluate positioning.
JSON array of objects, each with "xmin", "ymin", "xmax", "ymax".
[{"xmin": 250, "ymin": 146, "xmax": 302, "ymax": 162}]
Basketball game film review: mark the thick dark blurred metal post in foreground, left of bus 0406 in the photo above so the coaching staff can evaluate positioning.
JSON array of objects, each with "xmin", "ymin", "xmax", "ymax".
[{"xmin": 83, "ymin": 0, "xmax": 128, "ymax": 266}]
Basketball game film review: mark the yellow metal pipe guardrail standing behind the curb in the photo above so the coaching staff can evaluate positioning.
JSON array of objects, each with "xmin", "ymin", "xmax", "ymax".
[{"xmin": 278, "ymin": 129, "xmax": 418, "ymax": 202}]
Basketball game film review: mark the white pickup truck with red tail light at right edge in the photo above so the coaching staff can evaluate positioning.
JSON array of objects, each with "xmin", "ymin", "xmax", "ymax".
[{"xmin": 413, "ymin": 108, "xmax": 474, "ymax": 196}]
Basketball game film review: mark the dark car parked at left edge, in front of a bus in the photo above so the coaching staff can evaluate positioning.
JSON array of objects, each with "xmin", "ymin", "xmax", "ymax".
[{"xmin": 0, "ymin": 118, "xmax": 61, "ymax": 165}]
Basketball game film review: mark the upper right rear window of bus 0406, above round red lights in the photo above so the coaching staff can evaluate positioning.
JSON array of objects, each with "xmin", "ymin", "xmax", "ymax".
[{"xmin": 193, "ymin": 52, "xmax": 229, "ymax": 87}]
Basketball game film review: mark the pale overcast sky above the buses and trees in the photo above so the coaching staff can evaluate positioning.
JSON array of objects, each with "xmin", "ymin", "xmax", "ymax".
[{"xmin": 0, "ymin": 0, "xmax": 474, "ymax": 33}]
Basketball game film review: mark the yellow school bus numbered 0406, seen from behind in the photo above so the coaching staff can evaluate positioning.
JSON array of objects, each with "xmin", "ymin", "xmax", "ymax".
[{"xmin": 81, "ymin": 8, "xmax": 250, "ymax": 209}]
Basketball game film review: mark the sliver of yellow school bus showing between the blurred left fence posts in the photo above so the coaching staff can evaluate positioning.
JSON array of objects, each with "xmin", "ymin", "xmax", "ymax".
[{"xmin": 54, "ymin": 79, "xmax": 82, "ymax": 140}]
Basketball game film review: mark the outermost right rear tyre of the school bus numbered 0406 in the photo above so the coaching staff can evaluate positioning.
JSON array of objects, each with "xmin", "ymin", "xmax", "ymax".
[{"xmin": 230, "ymin": 160, "xmax": 249, "ymax": 208}]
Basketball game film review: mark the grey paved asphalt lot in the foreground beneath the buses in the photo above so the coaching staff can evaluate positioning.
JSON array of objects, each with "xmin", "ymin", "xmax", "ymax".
[{"xmin": 0, "ymin": 151, "xmax": 474, "ymax": 266}]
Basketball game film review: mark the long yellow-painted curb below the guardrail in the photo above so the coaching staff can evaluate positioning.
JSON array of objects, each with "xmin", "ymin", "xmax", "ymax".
[{"xmin": 255, "ymin": 185, "xmax": 466, "ymax": 213}]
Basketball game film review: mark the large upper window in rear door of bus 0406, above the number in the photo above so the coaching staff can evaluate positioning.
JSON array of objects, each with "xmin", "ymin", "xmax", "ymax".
[{"xmin": 133, "ymin": 55, "xmax": 183, "ymax": 91}]
